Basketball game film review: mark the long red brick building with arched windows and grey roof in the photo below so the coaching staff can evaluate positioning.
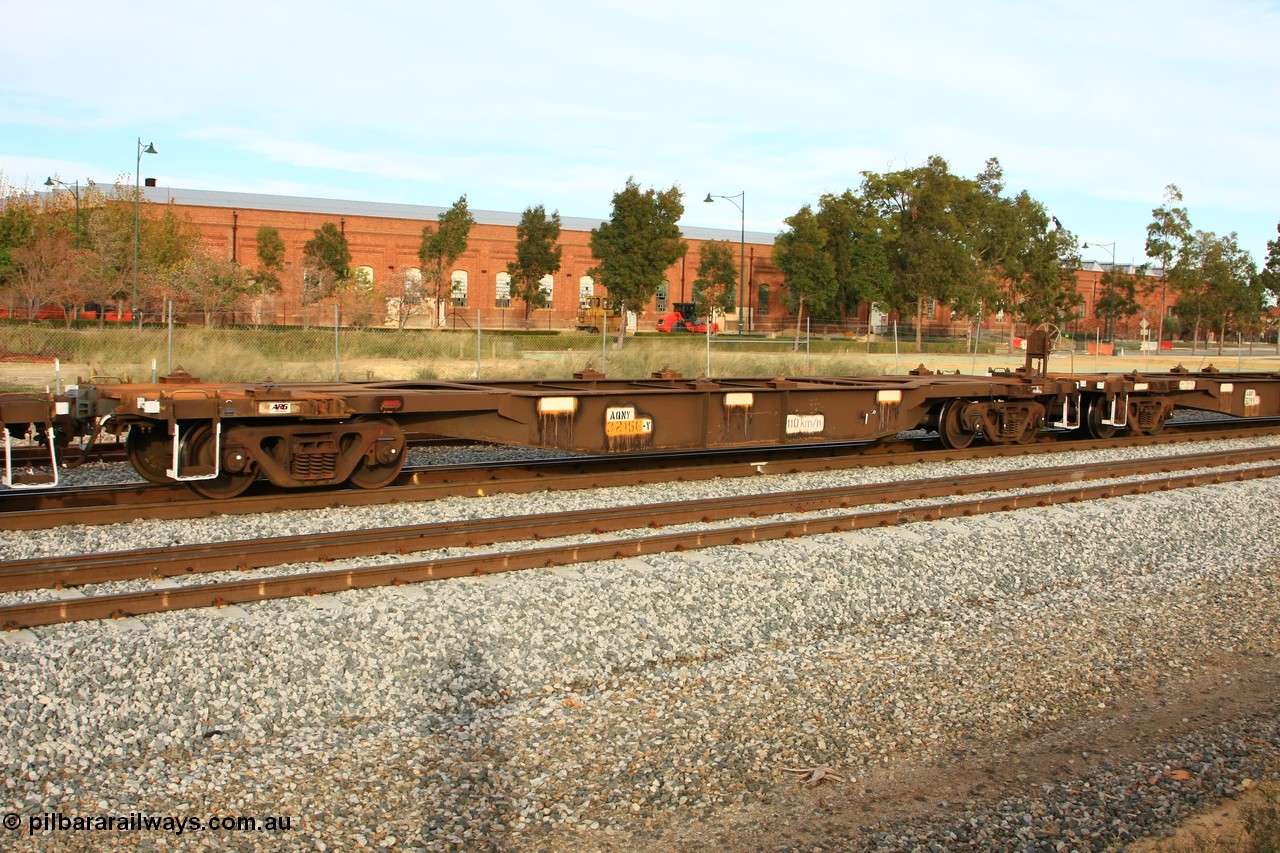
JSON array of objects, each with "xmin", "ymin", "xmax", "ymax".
[{"xmin": 145, "ymin": 187, "xmax": 786, "ymax": 330}]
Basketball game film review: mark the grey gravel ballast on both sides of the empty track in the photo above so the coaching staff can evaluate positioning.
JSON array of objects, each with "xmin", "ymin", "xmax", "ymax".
[{"xmin": 0, "ymin": 435, "xmax": 1280, "ymax": 850}]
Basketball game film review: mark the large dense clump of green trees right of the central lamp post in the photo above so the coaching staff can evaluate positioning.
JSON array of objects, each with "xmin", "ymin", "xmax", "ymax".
[{"xmin": 778, "ymin": 156, "xmax": 1080, "ymax": 342}]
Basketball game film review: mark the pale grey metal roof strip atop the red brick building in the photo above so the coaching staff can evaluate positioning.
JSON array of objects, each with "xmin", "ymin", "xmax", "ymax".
[{"xmin": 142, "ymin": 187, "xmax": 774, "ymax": 246}]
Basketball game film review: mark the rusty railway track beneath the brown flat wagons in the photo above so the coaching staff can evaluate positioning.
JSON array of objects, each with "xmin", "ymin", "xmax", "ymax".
[{"xmin": 0, "ymin": 419, "xmax": 1280, "ymax": 530}]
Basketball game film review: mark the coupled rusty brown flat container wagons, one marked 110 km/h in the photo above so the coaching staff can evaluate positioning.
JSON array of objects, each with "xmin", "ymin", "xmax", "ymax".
[{"xmin": 0, "ymin": 336, "xmax": 1280, "ymax": 498}]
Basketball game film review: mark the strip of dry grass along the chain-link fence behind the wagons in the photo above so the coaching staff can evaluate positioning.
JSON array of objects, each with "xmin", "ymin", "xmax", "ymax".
[{"xmin": 0, "ymin": 313, "xmax": 996, "ymax": 388}]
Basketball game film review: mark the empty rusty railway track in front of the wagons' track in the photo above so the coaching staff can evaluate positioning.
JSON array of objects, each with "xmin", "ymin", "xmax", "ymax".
[{"xmin": 0, "ymin": 440, "xmax": 1280, "ymax": 629}]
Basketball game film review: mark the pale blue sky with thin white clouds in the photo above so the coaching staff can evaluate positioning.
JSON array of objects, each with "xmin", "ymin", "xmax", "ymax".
[{"xmin": 0, "ymin": 0, "xmax": 1280, "ymax": 264}]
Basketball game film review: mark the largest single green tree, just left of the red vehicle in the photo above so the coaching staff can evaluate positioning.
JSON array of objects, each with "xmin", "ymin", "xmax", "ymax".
[{"xmin": 589, "ymin": 178, "xmax": 689, "ymax": 346}]
